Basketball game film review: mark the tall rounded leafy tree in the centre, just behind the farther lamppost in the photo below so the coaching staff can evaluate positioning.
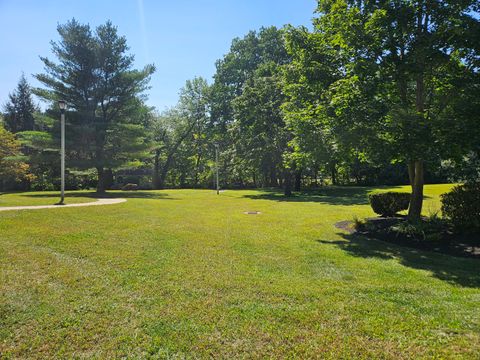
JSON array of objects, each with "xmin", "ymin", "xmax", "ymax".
[{"xmin": 210, "ymin": 27, "xmax": 291, "ymax": 190}]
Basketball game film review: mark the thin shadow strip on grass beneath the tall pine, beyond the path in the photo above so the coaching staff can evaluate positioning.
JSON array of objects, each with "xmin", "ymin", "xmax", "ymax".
[{"xmin": 18, "ymin": 191, "xmax": 175, "ymax": 200}]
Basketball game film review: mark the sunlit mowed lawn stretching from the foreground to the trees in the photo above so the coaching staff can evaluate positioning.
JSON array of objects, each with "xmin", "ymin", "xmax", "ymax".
[{"xmin": 0, "ymin": 185, "xmax": 480, "ymax": 359}]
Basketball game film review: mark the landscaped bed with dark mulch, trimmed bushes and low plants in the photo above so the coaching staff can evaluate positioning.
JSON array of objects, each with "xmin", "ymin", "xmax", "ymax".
[{"xmin": 335, "ymin": 182, "xmax": 480, "ymax": 258}]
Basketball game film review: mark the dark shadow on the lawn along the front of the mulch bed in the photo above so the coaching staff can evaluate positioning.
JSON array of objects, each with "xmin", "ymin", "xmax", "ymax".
[{"xmin": 317, "ymin": 233, "xmax": 480, "ymax": 288}]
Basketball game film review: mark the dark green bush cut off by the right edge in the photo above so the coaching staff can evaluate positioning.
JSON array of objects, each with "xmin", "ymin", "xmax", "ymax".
[{"xmin": 441, "ymin": 182, "xmax": 480, "ymax": 233}]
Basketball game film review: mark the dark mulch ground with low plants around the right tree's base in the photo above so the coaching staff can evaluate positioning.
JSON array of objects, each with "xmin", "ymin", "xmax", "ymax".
[{"xmin": 335, "ymin": 217, "xmax": 480, "ymax": 259}]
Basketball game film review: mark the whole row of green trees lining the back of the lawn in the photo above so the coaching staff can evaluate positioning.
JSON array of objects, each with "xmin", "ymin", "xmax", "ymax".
[{"xmin": 4, "ymin": 0, "xmax": 480, "ymax": 218}]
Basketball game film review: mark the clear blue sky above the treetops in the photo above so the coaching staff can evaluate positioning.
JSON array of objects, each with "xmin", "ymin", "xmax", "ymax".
[{"xmin": 0, "ymin": 0, "xmax": 316, "ymax": 110}]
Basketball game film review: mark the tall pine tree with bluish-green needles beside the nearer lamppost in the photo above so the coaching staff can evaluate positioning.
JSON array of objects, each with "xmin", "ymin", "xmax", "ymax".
[{"xmin": 36, "ymin": 19, "xmax": 155, "ymax": 191}]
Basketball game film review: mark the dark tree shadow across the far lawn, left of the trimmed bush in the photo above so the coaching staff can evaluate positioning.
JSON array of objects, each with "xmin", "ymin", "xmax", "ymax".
[{"xmin": 243, "ymin": 186, "xmax": 404, "ymax": 205}]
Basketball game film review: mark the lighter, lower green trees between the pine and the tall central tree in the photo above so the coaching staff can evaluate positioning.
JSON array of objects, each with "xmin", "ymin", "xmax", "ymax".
[{"xmin": 149, "ymin": 78, "xmax": 213, "ymax": 189}]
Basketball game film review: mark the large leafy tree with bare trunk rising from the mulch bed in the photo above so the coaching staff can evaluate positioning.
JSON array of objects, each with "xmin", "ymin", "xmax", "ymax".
[{"xmin": 284, "ymin": 0, "xmax": 480, "ymax": 217}]
